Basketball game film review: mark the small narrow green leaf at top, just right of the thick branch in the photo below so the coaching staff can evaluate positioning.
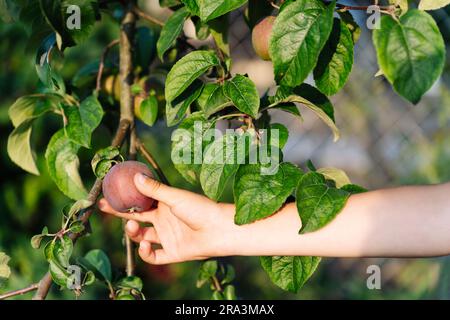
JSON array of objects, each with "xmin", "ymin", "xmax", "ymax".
[{"xmin": 156, "ymin": 7, "xmax": 190, "ymax": 61}]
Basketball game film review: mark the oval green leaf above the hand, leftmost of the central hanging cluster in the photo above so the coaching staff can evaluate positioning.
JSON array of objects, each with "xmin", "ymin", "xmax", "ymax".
[{"xmin": 171, "ymin": 112, "xmax": 214, "ymax": 184}]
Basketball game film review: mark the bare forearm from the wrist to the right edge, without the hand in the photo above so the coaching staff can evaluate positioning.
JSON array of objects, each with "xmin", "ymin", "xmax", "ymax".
[{"xmin": 227, "ymin": 184, "xmax": 450, "ymax": 257}]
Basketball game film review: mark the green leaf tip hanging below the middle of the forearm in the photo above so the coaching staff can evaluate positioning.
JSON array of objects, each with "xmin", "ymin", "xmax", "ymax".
[{"xmin": 261, "ymin": 256, "xmax": 320, "ymax": 292}]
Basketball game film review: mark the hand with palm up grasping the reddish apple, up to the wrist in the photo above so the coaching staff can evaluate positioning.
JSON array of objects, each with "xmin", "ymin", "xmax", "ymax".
[{"xmin": 98, "ymin": 174, "xmax": 235, "ymax": 264}]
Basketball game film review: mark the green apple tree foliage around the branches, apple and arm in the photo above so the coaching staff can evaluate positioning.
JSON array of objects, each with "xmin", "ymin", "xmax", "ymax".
[{"xmin": 0, "ymin": 0, "xmax": 450, "ymax": 299}]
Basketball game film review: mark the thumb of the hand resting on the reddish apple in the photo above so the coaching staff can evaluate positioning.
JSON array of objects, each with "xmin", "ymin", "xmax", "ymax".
[{"xmin": 134, "ymin": 173, "xmax": 187, "ymax": 207}]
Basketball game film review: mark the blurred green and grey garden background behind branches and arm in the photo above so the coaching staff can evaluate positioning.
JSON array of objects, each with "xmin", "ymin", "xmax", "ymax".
[{"xmin": 0, "ymin": 1, "xmax": 450, "ymax": 299}]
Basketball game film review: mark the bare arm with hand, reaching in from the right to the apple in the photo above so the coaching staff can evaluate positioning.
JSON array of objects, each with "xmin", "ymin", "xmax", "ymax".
[{"xmin": 99, "ymin": 176, "xmax": 450, "ymax": 264}]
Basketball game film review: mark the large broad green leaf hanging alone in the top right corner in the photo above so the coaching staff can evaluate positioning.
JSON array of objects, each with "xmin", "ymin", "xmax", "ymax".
[{"xmin": 373, "ymin": 10, "xmax": 445, "ymax": 104}]
